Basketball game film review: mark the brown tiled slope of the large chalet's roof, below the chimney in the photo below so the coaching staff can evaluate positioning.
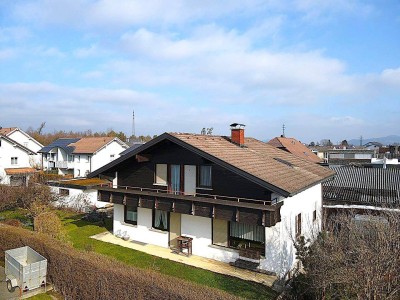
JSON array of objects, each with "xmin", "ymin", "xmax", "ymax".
[{"xmin": 171, "ymin": 133, "xmax": 335, "ymax": 194}]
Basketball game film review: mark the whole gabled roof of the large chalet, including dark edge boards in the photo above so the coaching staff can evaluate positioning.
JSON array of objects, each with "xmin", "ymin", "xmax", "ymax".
[{"xmin": 89, "ymin": 133, "xmax": 334, "ymax": 196}]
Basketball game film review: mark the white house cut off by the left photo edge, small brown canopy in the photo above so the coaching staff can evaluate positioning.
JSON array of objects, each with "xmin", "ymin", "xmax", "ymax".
[{"xmin": 0, "ymin": 134, "xmax": 36, "ymax": 185}]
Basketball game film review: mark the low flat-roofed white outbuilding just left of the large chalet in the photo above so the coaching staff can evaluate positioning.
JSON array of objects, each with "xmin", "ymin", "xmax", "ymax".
[{"xmin": 46, "ymin": 178, "xmax": 110, "ymax": 211}]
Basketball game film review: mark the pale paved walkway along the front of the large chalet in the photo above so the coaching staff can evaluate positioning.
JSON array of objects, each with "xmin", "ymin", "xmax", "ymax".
[{"xmin": 91, "ymin": 232, "xmax": 277, "ymax": 287}]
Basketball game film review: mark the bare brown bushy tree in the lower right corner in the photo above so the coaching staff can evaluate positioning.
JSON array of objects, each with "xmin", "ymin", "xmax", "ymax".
[{"xmin": 294, "ymin": 211, "xmax": 400, "ymax": 299}]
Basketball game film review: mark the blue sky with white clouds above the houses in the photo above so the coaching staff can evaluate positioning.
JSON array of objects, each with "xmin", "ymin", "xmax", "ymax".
[{"xmin": 0, "ymin": 0, "xmax": 400, "ymax": 142}]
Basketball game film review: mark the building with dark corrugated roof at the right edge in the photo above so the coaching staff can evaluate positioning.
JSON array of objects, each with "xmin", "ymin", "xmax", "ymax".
[{"xmin": 322, "ymin": 166, "xmax": 400, "ymax": 215}]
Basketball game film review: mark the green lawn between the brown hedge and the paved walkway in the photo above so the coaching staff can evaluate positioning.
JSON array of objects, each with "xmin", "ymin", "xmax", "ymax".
[{"xmin": 0, "ymin": 211, "xmax": 277, "ymax": 299}]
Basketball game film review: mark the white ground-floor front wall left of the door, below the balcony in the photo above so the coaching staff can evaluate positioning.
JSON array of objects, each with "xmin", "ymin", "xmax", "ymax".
[{"xmin": 114, "ymin": 204, "xmax": 169, "ymax": 248}]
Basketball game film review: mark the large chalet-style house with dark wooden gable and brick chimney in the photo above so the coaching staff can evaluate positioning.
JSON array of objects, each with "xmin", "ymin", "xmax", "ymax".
[{"xmin": 88, "ymin": 124, "xmax": 334, "ymax": 277}]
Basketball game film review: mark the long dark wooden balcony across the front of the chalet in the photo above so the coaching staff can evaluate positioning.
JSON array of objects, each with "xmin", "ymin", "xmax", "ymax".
[{"xmin": 97, "ymin": 186, "xmax": 283, "ymax": 227}]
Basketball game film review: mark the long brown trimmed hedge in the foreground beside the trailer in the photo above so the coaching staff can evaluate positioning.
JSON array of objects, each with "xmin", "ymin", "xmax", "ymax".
[{"xmin": 0, "ymin": 225, "xmax": 236, "ymax": 300}]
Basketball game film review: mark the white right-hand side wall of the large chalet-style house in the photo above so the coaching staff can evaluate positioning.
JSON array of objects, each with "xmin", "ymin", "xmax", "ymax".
[{"xmin": 261, "ymin": 184, "xmax": 322, "ymax": 277}]
